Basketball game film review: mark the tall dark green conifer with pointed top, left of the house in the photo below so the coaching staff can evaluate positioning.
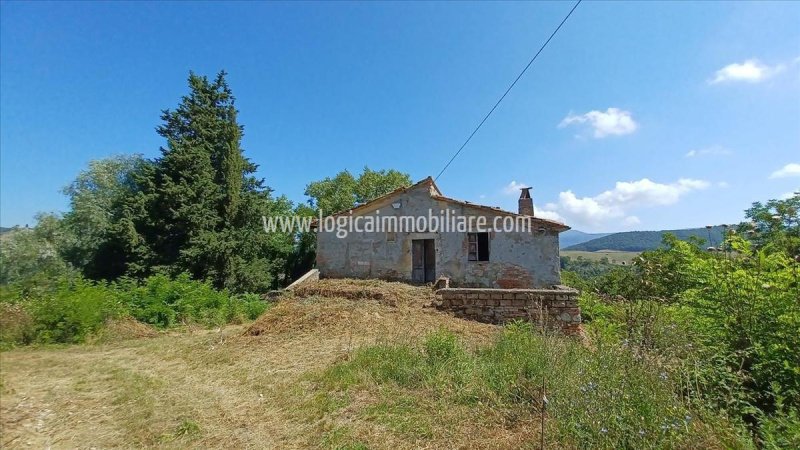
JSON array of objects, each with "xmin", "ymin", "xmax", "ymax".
[{"xmin": 129, "ymin": 68, "xmax": 292, "ymax": 292}]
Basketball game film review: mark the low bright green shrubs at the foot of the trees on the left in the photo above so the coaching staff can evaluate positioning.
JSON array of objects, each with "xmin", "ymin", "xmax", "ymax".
[{"xmin": 0, "ymin": 274, "xmax": 268, "ymax": 346}]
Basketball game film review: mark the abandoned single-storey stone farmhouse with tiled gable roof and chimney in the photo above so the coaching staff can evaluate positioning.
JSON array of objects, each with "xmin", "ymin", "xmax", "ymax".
[{"xmin": 316, "ymin": 177, "xmax": 569, "ymax": 289}]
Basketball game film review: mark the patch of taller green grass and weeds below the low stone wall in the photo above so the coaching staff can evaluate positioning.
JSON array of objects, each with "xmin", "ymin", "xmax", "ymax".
[{"xmin": 310, "ymin": 324, "xmax": 749, "ymax": 448}]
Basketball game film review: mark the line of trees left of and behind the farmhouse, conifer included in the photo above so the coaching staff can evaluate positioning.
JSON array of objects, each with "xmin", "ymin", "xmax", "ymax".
[{"xmin": 0, "ymin": 71, "xmax": 411, "ymax": 293}]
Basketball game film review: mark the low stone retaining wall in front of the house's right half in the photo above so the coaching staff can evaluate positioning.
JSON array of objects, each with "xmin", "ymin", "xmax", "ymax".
[{"xmin": 436, "ymin": 286, "xmax": 581, "ymax": 335}]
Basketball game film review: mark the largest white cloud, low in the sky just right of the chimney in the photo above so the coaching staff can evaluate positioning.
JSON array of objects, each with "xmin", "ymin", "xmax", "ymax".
[{"xmin": 536, "ymin": 178, "xmax": 711, "ymax": 229}]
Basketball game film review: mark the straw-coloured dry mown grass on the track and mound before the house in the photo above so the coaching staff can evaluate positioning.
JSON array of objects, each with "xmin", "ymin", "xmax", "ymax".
[{"xmin": 0, "ymin": 280, "xmax": 512, "ymax": 448}]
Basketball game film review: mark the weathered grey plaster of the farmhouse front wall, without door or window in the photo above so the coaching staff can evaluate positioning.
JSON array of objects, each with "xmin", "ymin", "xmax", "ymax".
[{"xmin": 317, "ymin": 179, "xmax": 566, "ymax": 288}]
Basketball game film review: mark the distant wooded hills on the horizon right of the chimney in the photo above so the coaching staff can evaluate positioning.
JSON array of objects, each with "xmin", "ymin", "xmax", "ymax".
[{"xmin": 562, "ymin": 226, "xmax": 723, "ymax": 252}]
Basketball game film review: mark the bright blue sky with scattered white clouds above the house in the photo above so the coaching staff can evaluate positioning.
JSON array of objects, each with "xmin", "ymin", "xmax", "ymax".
[{"xmin": 0, "ymin": 1, "xmax": 800, "ymax": 232}]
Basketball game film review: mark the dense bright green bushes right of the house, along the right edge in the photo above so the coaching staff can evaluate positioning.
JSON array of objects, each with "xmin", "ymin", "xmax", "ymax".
[{"xmin": 568, "ymin": 220, "xmax": 800, "ymax": 445}]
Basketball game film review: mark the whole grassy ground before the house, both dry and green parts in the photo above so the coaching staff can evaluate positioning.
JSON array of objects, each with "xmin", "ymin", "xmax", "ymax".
[{"xmin": 0, "ymin": 280, "xmax": 752, "ymax": 449}]
